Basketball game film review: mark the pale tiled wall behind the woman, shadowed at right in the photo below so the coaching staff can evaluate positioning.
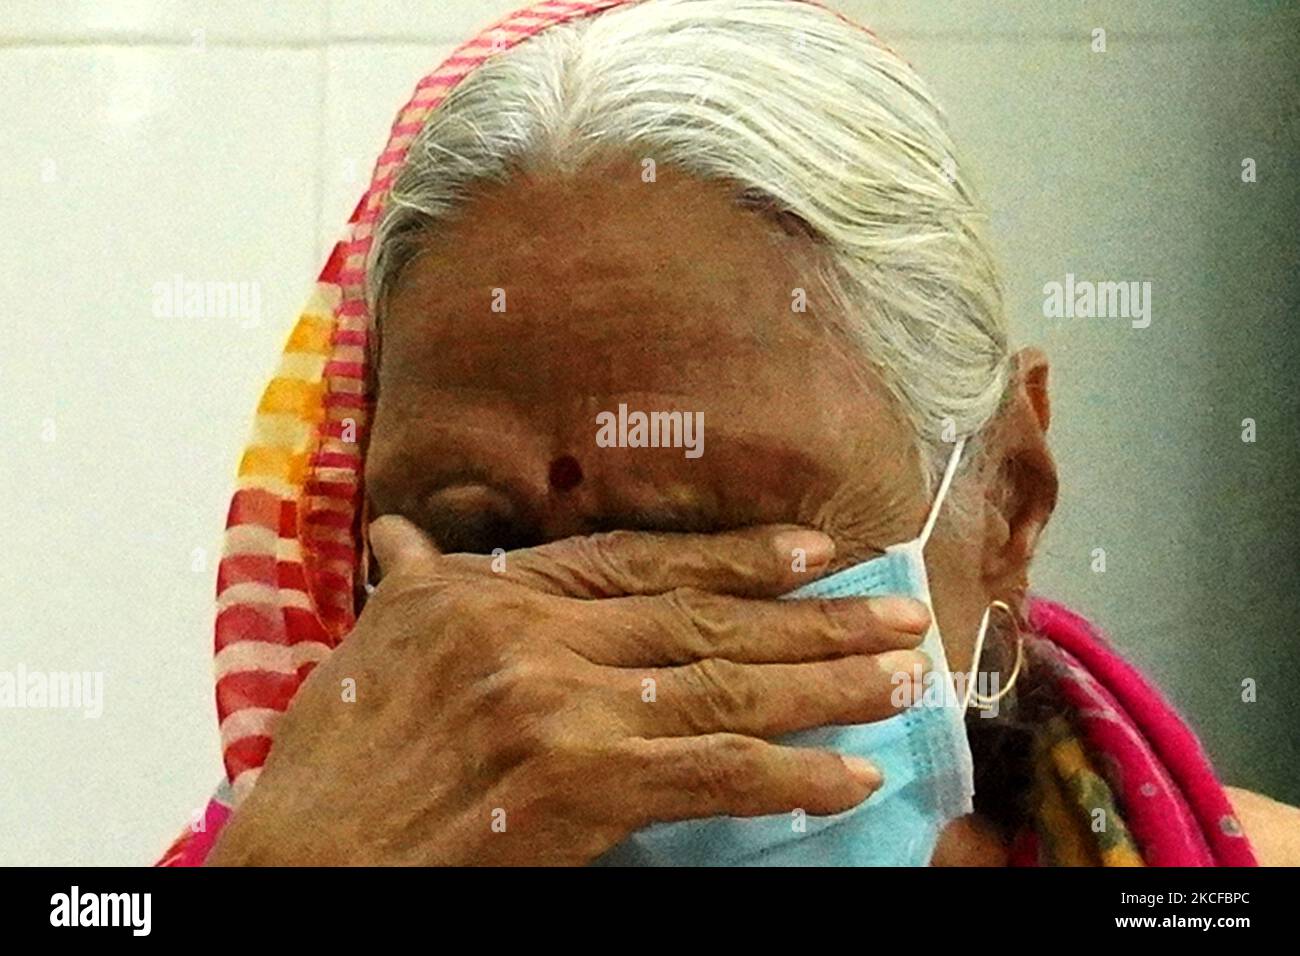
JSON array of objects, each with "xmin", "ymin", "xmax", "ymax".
[{"xmin": 0, "ymin": 0, "xmax": 1300, "ymax": 864}]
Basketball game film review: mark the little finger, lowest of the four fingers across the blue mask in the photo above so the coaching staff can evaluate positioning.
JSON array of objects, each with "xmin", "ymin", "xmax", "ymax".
[{"xmin": 623, "ymin": 734, "xmax": 884, "ymax": 826}]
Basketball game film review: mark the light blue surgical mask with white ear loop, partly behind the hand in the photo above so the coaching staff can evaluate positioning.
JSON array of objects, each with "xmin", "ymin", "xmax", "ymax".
[{"xmin": 597, "ymin": 441, "xmax": 975, "ymax": 866}]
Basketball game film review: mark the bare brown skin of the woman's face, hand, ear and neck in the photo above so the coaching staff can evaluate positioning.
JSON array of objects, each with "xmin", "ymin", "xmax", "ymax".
[{"xmin": 211, "ymin": 157, "xmax": 1295, "ymax": 865}]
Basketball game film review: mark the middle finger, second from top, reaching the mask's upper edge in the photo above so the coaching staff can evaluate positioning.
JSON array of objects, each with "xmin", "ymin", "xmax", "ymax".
[{"xmin": 560, "ymin": 588, "xmax": 930, "ymax": 667}]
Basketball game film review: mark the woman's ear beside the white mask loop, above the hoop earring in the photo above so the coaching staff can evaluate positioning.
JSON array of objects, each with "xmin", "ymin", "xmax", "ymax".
[{"xmin": 983, "ymin": 349, "xmax": 1057, "ymax": 600}]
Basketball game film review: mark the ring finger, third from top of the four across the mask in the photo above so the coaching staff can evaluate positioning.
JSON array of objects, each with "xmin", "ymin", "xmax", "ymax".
[{"xmin": 613, "ymin": 650, "xmax": 930, "ymax": 739}]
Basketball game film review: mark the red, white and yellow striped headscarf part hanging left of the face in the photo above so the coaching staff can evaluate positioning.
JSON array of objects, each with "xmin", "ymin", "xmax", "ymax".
[{"xmin": 216, "ymin": 0, "xmax": 642, "ymax": 803}]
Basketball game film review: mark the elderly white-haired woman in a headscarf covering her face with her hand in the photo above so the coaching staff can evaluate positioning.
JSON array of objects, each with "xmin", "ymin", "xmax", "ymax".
[{"xmin": 163, "ymin": 0, "xmax": 1300, "ymax": 865}]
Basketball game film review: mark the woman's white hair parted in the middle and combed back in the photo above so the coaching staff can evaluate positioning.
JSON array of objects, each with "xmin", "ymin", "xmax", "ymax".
[{"xmin": 368, "ymin": 0, "xmax": 1010, "ymax": 488}]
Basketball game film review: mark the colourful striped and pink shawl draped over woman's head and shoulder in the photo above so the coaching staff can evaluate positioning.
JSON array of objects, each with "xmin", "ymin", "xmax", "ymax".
[{"xmin": 159, "ymin": 0, "xmax": 1253, "ymax": 866}]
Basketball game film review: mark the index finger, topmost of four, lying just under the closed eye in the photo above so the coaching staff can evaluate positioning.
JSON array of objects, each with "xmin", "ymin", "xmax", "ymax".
[{"xmin": 504, "ymin": 524, "xmax": 835, "ymax": 598}]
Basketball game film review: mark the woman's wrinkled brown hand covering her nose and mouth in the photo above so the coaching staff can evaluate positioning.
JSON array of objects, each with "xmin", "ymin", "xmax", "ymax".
[{"xmin": 208, "ymin": 516, "xmax": 928, "ymax": 865}]
